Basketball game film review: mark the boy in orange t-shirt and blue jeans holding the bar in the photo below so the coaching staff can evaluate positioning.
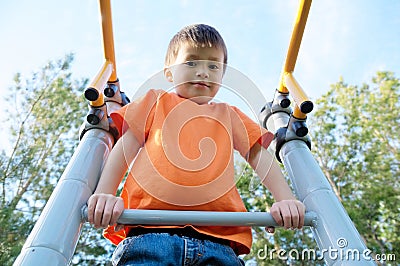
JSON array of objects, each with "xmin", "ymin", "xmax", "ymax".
[{"xmin": 88, "ymin": 24, "xmax": 305, "ymax": 265}]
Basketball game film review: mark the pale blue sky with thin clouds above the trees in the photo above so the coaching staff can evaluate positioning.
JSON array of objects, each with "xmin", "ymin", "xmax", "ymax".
[{"xmin": 0, "ymin": 0, "xmax": 400, "ymax": 150}]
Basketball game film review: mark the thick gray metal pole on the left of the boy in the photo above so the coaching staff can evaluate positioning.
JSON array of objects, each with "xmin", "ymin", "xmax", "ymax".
[{"xmin": 14, "ymin": 129, "xmax": 113, "ymax": 266}]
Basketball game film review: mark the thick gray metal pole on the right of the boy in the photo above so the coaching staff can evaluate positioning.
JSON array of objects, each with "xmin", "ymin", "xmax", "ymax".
[{"xmin": 260, "ymin": 105, "xmax": 376, "ymax": 265}]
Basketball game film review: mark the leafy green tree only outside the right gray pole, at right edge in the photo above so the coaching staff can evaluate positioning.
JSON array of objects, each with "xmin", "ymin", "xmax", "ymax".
[{"xmin": 310, "ymin": 72, "xmax": 400, "ymax": 257}]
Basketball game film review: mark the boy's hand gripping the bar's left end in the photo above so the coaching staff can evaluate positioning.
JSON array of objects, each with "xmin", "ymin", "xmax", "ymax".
[{"xmin": 88, "ymin": 193, "xmax": 124, "ymax": 231}]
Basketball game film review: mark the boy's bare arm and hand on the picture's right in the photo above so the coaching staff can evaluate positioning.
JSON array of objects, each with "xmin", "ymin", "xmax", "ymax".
[{"xmin": 247, "ymin": 143, "xmax": 305, "ymax": 231}]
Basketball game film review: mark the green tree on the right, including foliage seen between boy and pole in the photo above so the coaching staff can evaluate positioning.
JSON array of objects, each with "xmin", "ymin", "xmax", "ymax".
[{"xmin": 237, "ymin": 72, "xmax": 400, "ymax": 265}]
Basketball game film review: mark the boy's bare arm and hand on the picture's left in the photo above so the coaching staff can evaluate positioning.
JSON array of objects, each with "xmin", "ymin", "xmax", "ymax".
[{"xmin": 88, "ymin": 130, "xmax": 141, "ymax": 228}]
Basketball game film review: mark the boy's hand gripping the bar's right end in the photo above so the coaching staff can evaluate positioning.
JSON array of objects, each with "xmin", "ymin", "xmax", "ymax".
[{"xmin": 266, "ymin": 200, "xmax": 306, "ymax": 233}]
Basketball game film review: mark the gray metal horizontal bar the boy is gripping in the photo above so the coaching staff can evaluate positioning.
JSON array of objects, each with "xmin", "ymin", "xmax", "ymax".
[{"xmin": 82, "ymin": 206, "xmax": 317, "ymax": 227}]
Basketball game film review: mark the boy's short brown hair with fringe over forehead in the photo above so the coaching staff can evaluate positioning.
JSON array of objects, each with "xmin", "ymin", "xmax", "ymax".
[{"xmin": 165, "ymin": 24, "xmax": 228, "ymax": 69}]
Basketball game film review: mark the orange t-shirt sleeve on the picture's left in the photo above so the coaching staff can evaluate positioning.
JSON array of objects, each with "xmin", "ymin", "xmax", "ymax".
[{"xmin": 110, "ymin": 90, "xmax": 161, "ymax": 145}]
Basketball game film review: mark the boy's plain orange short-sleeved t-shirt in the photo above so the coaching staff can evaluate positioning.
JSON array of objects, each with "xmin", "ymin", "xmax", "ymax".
[{"xmin": 104, "ymin": 90, "xmax": 273, "ymax": 254}]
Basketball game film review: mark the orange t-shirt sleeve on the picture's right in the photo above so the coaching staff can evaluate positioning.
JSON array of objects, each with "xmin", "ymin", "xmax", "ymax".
[{"xmin": 231, "ymin": 106, "xmax": 274, "ymax": 157}]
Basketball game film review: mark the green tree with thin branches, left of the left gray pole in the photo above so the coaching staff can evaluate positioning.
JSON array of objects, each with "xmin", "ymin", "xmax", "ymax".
[{"xmin": 0, "ymin": 54, "xmax": 111, "ymax": 265}]
